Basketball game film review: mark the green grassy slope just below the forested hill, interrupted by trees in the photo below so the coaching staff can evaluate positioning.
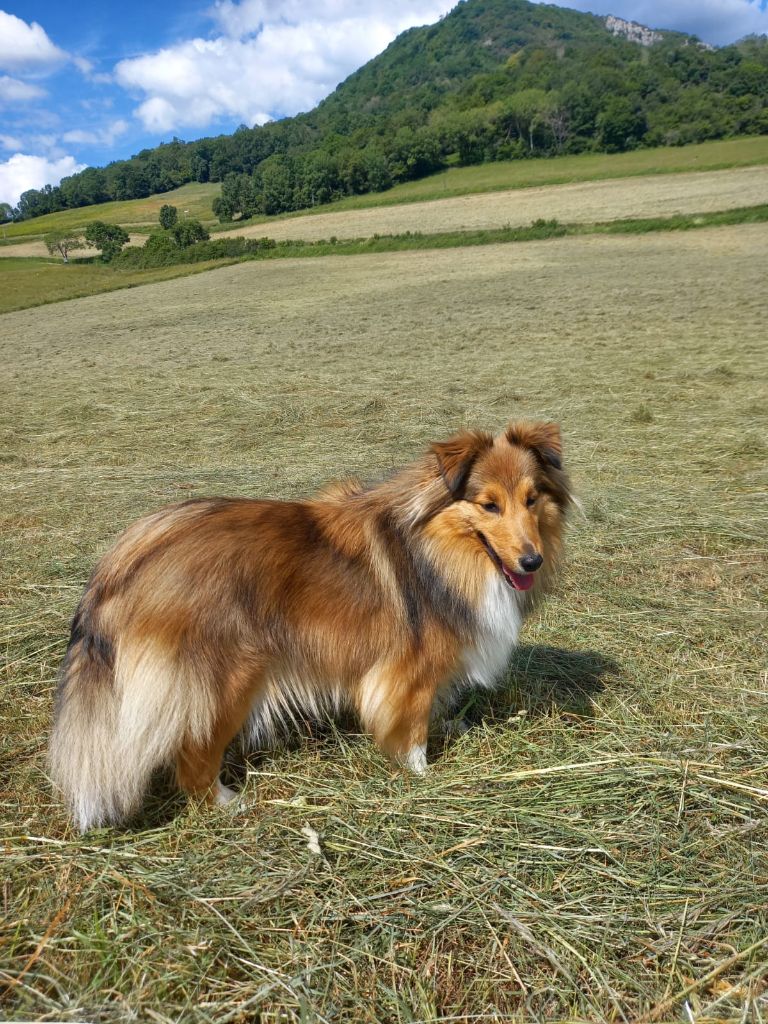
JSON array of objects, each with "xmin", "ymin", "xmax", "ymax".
[{"xmin": 6, "ymin": 136, "xmax": 768, "ymax": 243}]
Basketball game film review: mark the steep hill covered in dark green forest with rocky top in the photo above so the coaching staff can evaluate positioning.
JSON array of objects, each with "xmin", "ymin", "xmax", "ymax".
[{"xmin": 15, "ymin": 0, "xmax": 768, "ymax": 219}]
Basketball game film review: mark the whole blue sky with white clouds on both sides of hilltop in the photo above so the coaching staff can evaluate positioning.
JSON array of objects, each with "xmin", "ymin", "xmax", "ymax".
[{"xmin": 0, "ymin": 0, "xmax": 768, "ymax": 205}]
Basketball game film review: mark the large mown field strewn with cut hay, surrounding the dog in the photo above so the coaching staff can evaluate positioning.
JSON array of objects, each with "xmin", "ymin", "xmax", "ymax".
[{"xmin": 0, "ymin": 224, "xmax": 768, "ymax": 1024}]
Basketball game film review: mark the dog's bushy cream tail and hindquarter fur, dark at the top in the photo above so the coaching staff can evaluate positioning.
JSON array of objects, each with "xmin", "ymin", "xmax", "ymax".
[{"xmin": 49, "ymin": 622, "xmax": 213, "ymax": 831}]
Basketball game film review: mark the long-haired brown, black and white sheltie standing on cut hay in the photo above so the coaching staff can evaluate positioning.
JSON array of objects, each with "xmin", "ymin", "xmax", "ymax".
[{"xmin": 50, "ymin": 423, "xmax": 570, "ymax": 830}]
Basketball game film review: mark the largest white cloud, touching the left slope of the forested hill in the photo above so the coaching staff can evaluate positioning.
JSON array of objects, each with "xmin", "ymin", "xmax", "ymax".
[{"xmin": 115, "ymin": 0, "xmax": 455, "ymax": 133}]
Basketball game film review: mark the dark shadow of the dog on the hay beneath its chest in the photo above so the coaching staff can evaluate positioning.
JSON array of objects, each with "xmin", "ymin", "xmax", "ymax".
[{"xmin": 446, "ymin": 644, "xmax": 620, "ymax": 743}]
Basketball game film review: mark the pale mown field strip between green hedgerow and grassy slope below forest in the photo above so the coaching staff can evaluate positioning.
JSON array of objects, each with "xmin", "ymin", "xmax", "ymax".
[{"xmin": 216, "ymin": 167, "xmax": 768, "ymax": 242}]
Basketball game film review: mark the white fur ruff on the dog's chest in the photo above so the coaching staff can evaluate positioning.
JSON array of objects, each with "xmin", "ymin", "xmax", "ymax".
[{"xmin": 464, "ymin": 572, "xmax": 523, "ymax": 687}]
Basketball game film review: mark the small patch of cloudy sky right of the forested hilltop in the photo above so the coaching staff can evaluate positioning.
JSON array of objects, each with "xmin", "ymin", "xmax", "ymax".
[{"xmin": 558, "ymin": 0, "xmax": 768, "ymax": 46}]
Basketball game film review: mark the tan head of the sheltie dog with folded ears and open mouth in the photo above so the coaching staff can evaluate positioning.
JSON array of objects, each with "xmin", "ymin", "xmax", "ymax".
[{"xmin": 430, "ymin": 422, "xmax": 570, "ymax": 591}]
